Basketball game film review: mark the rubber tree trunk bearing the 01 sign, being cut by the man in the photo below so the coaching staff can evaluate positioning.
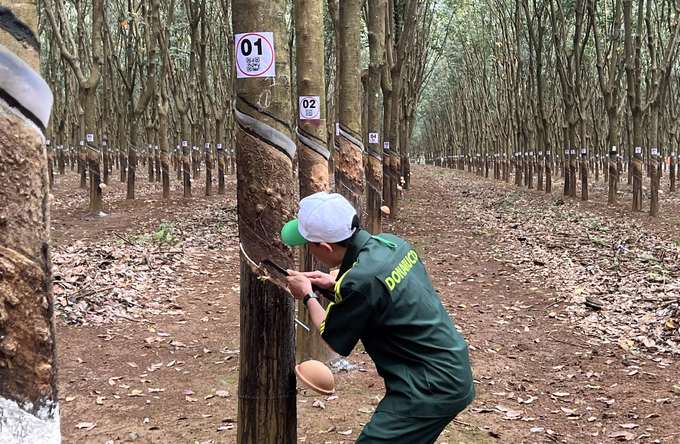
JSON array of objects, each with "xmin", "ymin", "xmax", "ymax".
[{"xmin": 232, "ymin": 0, "xmax": 297, "ymax": 444}]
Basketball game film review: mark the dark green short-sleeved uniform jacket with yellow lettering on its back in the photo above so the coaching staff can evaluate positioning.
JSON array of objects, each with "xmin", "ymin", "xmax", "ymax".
[{"xmin": 321, "ymin": 231, "xmax": 475, "ymax": 417}]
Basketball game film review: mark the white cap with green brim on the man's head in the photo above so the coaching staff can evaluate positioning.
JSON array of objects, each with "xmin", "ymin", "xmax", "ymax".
[{"xmin": 281, "ymin": 191, "xmax": 357, "ymax": 245}]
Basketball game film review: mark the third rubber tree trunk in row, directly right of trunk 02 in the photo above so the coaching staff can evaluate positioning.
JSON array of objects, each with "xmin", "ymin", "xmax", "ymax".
[{"xmin": 334, "ymin": 0, "xmax": 364, "ymax": 217}]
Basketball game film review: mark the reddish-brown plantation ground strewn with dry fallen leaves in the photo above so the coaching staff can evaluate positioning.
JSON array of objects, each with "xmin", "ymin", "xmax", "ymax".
[{"xmin": 51, "ymin": 165, "xmax": 680, "ymax": 444}]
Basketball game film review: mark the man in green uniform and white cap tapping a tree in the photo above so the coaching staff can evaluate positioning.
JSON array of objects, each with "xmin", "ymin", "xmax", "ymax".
[{"xmin": 281, "ymin": 192, "xmax": 475, "ymax": 444}]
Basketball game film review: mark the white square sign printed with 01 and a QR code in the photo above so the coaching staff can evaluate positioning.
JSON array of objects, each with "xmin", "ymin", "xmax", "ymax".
[{"xmin": 235, "ymin": 32, "xmax": 276, "ymax": 79}]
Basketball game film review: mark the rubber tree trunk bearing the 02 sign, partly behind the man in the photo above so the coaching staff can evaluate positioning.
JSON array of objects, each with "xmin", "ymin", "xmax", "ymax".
[{"xmin": 295, "ymin": 0, "xmax": 337, "ymax": 362}]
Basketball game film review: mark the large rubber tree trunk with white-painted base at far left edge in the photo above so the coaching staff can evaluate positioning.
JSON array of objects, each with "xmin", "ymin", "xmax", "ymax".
[{"xmin": 0, "ymin": 5, "xmax": 61, "ymax": 444}]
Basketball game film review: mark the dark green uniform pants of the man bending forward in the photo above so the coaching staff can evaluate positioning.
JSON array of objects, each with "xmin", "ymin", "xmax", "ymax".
[{"xmin": 355, "ymin": 412, "xmax": 456, "ymax": 444}]
